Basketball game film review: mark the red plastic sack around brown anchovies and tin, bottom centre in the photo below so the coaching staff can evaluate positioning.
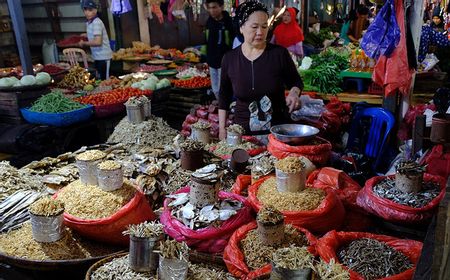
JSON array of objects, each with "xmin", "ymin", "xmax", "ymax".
[{"xmin": 223, "ymin": 221, "xmax": 317, "ymax": 280}]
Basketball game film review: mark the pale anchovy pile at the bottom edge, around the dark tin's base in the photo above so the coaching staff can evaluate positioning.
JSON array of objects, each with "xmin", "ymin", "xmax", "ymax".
[{"xmin": 90, "ymin": 255, "xmax": 158, "ymax": 280}]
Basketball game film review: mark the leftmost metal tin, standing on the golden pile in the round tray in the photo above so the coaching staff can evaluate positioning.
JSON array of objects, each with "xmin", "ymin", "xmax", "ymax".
[{"xmin": 29, "ymin": 211, "xmax": 64, "ymax": 243}]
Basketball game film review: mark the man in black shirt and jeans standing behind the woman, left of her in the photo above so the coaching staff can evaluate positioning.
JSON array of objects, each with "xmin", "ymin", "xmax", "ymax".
[{"xmin": 205, "ymin": 0, "xmax": 234, "ymax": 100}]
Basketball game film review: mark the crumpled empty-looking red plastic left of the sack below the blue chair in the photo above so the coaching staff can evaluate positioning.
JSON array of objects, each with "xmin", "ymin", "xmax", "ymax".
[{"xmin": 306, "ymin": 167, "xmax": 361, "ymax": 209}]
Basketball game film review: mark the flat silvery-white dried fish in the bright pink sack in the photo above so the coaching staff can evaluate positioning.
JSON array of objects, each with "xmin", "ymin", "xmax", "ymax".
[{"xmin": 166, "ymin": 193, "xmax": 243, "ymax": 230}]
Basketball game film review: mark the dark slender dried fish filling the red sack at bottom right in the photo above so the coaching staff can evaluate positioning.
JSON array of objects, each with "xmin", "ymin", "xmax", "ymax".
[{"xmin": 337, "ymin": 238, "xmax": 413, "ymax": 280}]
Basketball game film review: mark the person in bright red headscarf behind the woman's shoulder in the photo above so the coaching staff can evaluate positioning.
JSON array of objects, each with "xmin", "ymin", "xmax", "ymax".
[{"xmin": 270, "ymin": 8, "xmax": 305, "ymax": 57}]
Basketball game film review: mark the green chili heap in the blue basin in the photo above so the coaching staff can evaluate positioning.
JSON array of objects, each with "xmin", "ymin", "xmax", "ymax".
[{"xmin": 30, "ymin": 91, "xmax": 86, "ymax": 113}]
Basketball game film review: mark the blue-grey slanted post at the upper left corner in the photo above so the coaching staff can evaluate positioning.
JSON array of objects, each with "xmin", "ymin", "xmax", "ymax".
[{"xmin": 8, "ymin": 0, "xmax": 33, "ymax": 75}]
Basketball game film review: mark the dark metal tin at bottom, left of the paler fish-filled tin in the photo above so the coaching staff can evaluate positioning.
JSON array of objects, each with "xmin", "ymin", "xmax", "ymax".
[{"xmin": 128, "ymin": 236, "xmax": 163, "ymax": 272}]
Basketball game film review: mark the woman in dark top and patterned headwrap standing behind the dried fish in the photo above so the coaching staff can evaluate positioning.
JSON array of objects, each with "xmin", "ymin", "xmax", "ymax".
[{"xmin": 219, "ymin": 0, "xmax": 303, "ymax": 139}]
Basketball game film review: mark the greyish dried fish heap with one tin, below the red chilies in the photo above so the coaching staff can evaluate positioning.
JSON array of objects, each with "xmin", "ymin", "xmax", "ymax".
[{"xmin": 108, "ymin": 116, "xmax": 178, "ymax": 152}]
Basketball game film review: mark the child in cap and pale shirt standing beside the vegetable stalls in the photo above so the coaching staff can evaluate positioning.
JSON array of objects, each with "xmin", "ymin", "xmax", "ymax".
[{"xmin": 78, "ymin": 0, "xmax": 112, "ymax": 80}]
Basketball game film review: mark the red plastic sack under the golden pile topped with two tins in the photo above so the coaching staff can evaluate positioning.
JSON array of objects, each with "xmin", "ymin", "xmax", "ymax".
[{"xmin": 53, "ymin": 190, "xmax": 156, "ymax": 246}]
